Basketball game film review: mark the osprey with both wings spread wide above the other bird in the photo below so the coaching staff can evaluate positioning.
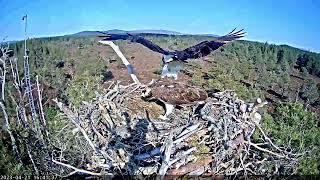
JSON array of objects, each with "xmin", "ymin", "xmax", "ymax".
[{"xmin": 99, "ymin": 29, "xmax": 245, "ymax": 79}]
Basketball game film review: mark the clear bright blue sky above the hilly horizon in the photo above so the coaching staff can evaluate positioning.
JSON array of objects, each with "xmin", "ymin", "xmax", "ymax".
[{"xmin": 0, "ymin": 0, "xmax": 320, "ymax": 52}]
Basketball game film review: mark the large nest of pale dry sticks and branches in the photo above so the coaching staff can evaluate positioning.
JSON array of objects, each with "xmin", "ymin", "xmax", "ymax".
[{"xmin": 52, "ymin": 83, "xmax": 297, "ymax": 176}]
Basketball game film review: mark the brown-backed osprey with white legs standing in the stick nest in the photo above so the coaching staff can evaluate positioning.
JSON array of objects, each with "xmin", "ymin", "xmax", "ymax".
[{"xmin": 142, "ymin": 80, "xmax": 208, "ymax": 119}]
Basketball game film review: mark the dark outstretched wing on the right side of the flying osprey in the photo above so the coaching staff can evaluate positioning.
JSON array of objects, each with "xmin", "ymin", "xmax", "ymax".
[{"xmin": 176, "ymin": 29, "xmax": 245, "ymax": 61}]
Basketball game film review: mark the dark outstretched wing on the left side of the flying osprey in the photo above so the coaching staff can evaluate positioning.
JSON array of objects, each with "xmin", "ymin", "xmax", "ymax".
[{"xmin": 97, "ymin": 31, "xmax": 170, "ymax": 55}]
